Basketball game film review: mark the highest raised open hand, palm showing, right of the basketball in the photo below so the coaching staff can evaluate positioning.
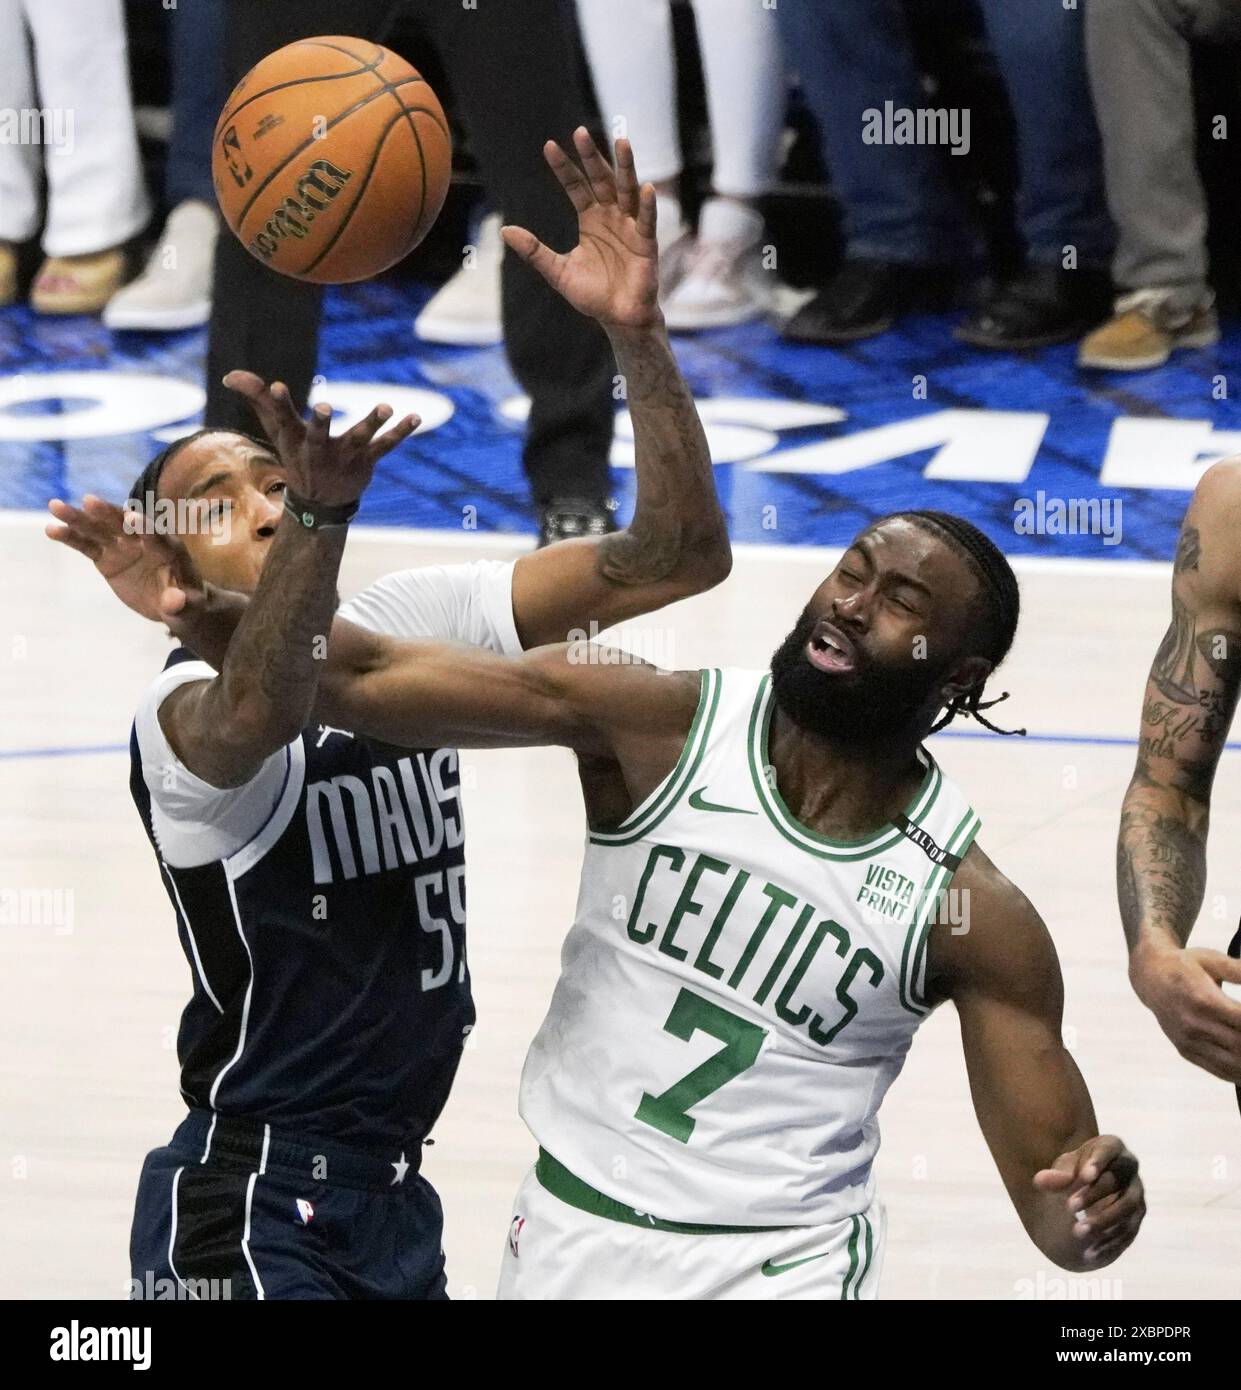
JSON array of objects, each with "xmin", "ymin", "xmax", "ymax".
[{"xmin": 502, "ymin": 126, "xmax": 663, "ymax": 336}]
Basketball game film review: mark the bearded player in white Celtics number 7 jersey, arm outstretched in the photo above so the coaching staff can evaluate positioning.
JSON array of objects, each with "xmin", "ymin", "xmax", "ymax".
[{"xmin": 94, "ymin": 512, "xmax": 1145, "ymax": 1300}]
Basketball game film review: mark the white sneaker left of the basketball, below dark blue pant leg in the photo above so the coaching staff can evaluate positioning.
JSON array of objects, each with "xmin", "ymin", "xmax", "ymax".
[{"xmin": 103, "ymin": 197, "xmax": 220, "ymax": 332}]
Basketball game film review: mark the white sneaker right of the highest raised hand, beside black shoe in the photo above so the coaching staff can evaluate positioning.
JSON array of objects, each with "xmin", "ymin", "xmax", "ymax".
[{"xmin": 664, "ymin": 197, "xmax": 775, "ymax": 332}]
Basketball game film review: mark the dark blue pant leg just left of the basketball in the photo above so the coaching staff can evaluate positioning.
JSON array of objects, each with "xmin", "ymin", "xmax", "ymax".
[{"xmin": 164, "ymin": 0, "xmax": 228, "ymax": 209}]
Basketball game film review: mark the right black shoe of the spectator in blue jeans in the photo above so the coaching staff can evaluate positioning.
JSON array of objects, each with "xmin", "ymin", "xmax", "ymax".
[{"xmin": 953, "ymin": 265, "xmax": 1112, "ymax": 352}]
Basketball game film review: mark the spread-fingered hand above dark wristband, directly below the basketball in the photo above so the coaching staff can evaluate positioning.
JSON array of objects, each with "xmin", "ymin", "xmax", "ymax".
[{"xmin": 224, "ymin": 371, "xmax": 422, "ymax": 506}]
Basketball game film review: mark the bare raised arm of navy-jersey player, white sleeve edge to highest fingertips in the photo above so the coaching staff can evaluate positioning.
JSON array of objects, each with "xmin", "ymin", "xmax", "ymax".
[{"xmin": 503, "ymin": 129, "xmax": 732, "ymax": 648}]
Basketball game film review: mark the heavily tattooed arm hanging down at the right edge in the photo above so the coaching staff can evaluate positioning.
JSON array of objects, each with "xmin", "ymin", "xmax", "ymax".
[{"xmin": 1116, "ymin": 460, "xmax": 1241, "ymax": 1083}]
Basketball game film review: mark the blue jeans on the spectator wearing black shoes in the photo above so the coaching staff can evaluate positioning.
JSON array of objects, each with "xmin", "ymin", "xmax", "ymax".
[{"xmin": 777, "ymin": 0, "xmax": 1113, "ymax": 265}]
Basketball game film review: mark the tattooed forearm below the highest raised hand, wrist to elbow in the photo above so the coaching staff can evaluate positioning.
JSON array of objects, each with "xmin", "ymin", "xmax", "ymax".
[{"xmin": 598, "ymin": 328, "xmax": 730, "ymax": 585}]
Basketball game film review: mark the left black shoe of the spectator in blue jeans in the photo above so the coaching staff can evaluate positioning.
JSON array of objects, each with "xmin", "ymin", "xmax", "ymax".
[{"xmin": 781, "ymin": 259, "xmax": 953, "ymax": 346}]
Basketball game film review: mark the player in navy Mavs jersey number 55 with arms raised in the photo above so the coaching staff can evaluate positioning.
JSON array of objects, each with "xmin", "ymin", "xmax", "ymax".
[{"xmin": 49, "ymin": 131, "xmax": 731, "ymax": 1298}]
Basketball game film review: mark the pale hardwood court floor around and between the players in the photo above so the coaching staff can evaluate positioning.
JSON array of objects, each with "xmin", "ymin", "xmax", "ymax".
[{"xmin": 0, "ymin": 514, "xmax": 1241, "ymax": 1298}]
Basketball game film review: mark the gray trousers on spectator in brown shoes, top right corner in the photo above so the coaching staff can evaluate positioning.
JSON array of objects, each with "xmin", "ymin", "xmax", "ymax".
[{"xmin": 1085, "ymin": 0, "xmax": 1241, "ymax": 310}]
